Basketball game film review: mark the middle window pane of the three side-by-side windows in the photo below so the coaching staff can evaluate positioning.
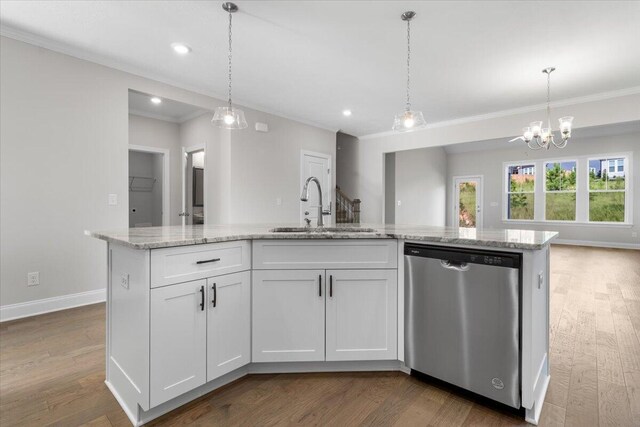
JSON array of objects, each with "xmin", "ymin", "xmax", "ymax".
[{"xmin": 544, "ymin": 161, "xmax": 576, "ymax": 221}]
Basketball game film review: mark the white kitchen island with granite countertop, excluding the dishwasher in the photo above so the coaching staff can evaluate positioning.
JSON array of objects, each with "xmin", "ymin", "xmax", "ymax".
[{"xmin": 89, "ymin": 224, "xmax": 557, "ymax": 425}]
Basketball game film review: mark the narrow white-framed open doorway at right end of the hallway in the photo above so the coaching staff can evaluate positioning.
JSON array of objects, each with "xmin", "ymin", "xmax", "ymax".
[{"xmin": 179, "ymin": 145, "xmax": 206, "ymax": 225}]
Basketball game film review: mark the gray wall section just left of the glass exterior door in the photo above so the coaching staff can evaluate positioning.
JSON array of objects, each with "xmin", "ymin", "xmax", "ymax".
[{"xmin": 395, "ymin": 147, "xmax": 447, "ymax": 226}]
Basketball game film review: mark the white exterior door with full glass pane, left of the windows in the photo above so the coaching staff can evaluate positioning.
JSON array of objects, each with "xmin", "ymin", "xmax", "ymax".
[{"xmin": 453, "ymin": 175, "xmax": 482, "ymax": 230}]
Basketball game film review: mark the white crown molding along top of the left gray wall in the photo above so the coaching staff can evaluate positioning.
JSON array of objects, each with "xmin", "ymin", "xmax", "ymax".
[{"xmin": 0, "ymin": 23, "xmax": 338, "ymax": 133}]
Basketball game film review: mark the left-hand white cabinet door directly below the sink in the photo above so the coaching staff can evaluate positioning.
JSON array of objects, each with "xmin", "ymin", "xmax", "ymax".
[{"xmin": 251, "ymin": 270, "xmax": 326, "ymax": 362}]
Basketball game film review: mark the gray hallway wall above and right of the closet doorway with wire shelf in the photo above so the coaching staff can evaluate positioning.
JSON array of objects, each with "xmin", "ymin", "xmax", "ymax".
[{"xmin": 129, "ymin": 114, "xmax": 182, "ymax": 225}]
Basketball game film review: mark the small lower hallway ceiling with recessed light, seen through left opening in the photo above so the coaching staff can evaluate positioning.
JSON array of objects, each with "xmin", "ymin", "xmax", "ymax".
[{"xmin": 129, "ymin": 90, "xmax": 205, "ymax": 123}]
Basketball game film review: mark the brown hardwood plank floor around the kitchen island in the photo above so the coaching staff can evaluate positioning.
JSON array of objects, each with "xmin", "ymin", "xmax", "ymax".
[{"xmin": 0, "ymin": 246, "xmax": 640, "ymax": 427}]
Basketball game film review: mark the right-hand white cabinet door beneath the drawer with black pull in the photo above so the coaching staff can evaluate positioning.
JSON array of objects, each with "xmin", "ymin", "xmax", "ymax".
[{"xmin": 207, "ymin": 271, "xmax": 251, "ymax": 381}]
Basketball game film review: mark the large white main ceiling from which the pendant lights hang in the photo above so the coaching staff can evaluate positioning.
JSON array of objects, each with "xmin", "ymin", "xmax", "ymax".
[{"xmin": 0, "ymin": 0, "xmax": 640, "ymax": 136}]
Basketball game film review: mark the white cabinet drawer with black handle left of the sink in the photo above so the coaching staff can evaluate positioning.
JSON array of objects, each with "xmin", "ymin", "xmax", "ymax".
[{"xmin": 151, "ymin": 240, "xmax": 251, "ymax": 288}]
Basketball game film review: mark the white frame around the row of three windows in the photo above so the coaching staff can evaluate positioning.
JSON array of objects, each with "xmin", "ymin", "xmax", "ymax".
[{"xmin": 502, "ymin": 152, "xmax": 634, "ymax": 228}]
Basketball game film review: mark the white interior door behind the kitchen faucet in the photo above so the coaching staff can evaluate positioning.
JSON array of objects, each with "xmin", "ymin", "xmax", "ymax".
[{"xmin": 300, "ymin": 151, "xmax": 333, "ymax": 225}]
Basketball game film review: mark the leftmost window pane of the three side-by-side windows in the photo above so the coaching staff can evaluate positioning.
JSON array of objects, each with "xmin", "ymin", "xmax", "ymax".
[{"xmin": 507, "ymin": 164, "xmax": 536, "ymax": 220}]
